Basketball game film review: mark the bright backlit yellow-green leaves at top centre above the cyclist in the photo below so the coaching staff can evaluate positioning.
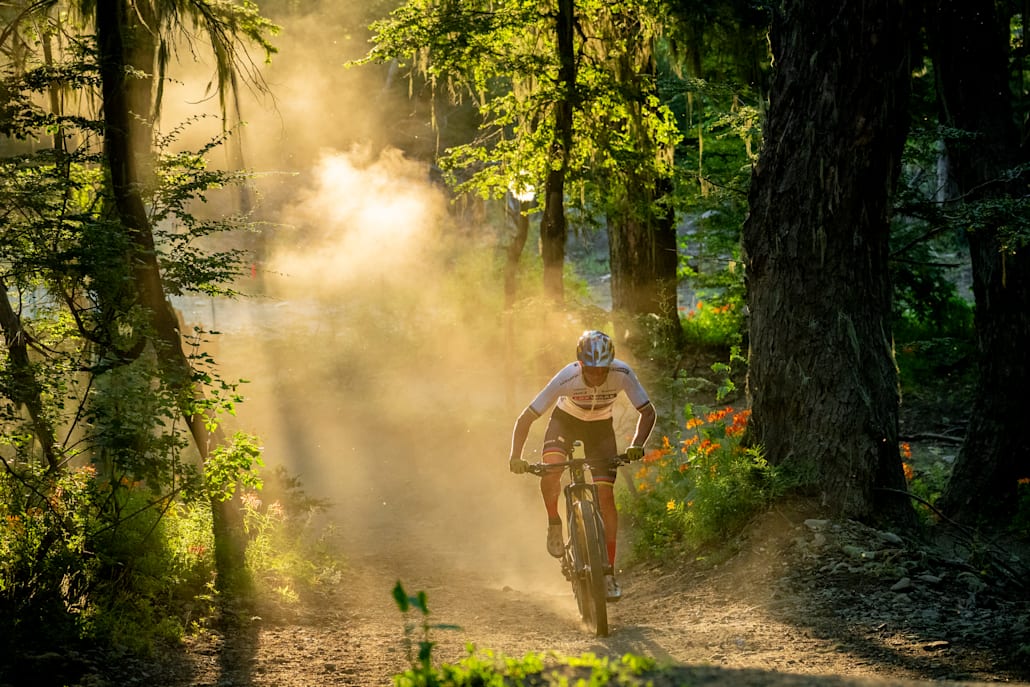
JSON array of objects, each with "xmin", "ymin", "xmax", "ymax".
[{"xmin": 354, "ymin": 0, "xmax": 680, "ymax": 242}]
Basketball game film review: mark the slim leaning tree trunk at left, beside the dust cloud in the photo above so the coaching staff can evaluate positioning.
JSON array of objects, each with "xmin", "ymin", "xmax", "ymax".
[{"xmin": 96, "ymin": 0, "xmax": 245, "ymax": 589}]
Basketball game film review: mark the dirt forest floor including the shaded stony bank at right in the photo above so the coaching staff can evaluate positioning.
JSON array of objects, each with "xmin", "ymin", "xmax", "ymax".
[{"xmin": 90, "ymin": 370, "xmax": 1030, "ymax": 687}]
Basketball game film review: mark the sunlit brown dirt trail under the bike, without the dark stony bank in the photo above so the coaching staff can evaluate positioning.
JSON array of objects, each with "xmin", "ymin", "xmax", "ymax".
[{"xmin": 145, "ymin": 484, "xmax": 1030, "ymax": 687}]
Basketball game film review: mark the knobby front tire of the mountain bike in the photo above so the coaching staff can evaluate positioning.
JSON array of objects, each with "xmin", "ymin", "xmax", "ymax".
[{"xmin": 571, "ymin": 501, "xmax": 608, "ymax": 637}]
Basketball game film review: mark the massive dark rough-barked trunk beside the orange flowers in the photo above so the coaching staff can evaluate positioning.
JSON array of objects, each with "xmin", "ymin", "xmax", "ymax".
[{"xmin": 743, "ymin": 0, "xmax": 915, "ymax": 525}]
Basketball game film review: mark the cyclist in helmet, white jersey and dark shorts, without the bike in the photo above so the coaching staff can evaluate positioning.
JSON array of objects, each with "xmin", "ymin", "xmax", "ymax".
[{"xmin": 508, "ymin": 330, "xmax": 657, "ymax": 600}]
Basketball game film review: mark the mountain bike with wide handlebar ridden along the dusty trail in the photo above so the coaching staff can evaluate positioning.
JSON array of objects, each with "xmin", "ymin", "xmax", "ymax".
[{"xmin": 528, "ymin": 442, "xmax": 628, "ymax": 637}]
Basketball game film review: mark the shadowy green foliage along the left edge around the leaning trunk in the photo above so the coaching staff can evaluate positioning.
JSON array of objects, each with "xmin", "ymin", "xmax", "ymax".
[{"xmin": 0, "ymin": 45, "xmax": 269, "ymax": 653}]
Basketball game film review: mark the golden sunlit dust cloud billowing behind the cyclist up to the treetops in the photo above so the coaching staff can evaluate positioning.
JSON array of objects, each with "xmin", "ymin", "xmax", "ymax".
[{"xmin": 163, "ymin": 2, "xmax": 631, "ymax": 596}]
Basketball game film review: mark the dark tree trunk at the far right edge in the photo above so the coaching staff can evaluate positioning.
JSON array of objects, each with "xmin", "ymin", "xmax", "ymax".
[{"xmin": 930, "ymin": 0, "xmax": 1030, "ymax": 523}]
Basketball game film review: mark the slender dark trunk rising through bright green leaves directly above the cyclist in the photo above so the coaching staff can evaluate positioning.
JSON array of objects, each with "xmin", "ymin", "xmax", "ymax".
[{"xmin": 540, "ymin": 0, "xmax": 576, "ymax": 306}]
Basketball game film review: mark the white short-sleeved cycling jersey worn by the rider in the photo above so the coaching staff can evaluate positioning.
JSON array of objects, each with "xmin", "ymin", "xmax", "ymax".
[{"xmin": 529, "ymin": 359, "xmax": 651, "ymax": 421}]
